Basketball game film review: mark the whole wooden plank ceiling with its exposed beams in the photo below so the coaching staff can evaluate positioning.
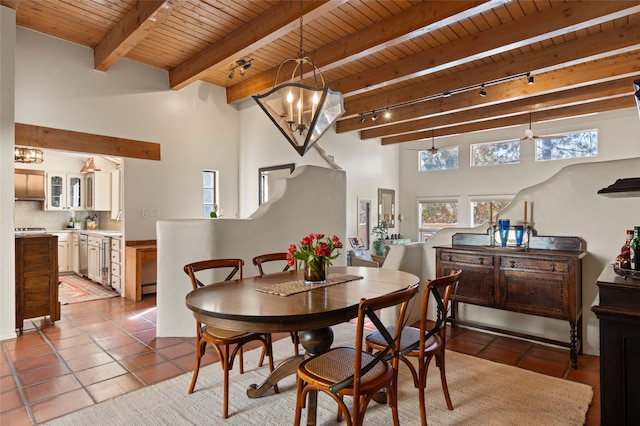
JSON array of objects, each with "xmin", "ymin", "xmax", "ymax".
[{"xmin": 5, "ymin": 0, "xmax": 640, "ymax": 144}]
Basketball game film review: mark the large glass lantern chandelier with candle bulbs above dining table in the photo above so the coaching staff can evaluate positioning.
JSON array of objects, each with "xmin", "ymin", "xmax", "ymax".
[{"xmin": 253, "ymin": 2, "xmax": 345, "ymax": 156}]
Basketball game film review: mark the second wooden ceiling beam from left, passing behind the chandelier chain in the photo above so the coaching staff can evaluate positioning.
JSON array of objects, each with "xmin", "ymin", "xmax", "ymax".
[{"xmin": 169, "ymin": 0, "xmax": 346, "ymax": 89}]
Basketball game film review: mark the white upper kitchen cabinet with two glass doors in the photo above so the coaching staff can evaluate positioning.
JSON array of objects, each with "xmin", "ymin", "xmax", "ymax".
[{"xmin": 45, "ymin": 172, "xmax": 85, "ymax": 210}]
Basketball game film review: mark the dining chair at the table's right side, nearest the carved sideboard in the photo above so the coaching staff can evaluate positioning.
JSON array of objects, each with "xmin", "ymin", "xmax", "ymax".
[{"xmin": 366, "ymin": 270, "xmax": 462, "ymax": 426}]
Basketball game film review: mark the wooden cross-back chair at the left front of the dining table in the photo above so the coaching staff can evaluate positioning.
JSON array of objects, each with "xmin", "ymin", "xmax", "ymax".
[{"xmin": 184, "ymin": 259, "xmax": 273, "ymax": 419}]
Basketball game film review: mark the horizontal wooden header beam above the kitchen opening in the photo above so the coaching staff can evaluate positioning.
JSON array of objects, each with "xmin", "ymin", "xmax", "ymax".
[{"xmin": 15, "ymin": 123, "xmax": 160, "ymax": 161}]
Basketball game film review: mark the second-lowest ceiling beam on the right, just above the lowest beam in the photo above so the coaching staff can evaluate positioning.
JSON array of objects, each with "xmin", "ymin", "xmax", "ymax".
[{"xmin": 360, "ymin": 78, "xmax": 633, "ymax": 139}]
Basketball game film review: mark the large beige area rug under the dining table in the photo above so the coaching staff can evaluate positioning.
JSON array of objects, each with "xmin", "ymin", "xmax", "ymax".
[{"xmin": 46, "ymin": 323, "xmax": 593, "ymax": 426}]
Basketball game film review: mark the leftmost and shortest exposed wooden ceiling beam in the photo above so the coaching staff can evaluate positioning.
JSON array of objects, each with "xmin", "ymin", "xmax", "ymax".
[{"xmin": 93, "ymin": 0, "xmax": 173, "ymax": 71}]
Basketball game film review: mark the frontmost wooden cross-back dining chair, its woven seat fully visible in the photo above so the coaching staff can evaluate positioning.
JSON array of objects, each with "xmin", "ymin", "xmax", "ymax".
[{"xmin": 294, "ymin": 284, "xmax": 419, "ymax": 426}]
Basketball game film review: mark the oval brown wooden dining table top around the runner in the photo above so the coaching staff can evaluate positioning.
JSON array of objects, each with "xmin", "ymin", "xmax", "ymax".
[{"xmin": 185, "ymin": 266, "xmax": 419, "ymax": 333}]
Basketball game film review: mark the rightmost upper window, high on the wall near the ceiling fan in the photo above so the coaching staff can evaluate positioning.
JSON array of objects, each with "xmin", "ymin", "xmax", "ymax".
[{"xmin": 536, "ymin": 130, "xmax": 598, "ymax": 161}]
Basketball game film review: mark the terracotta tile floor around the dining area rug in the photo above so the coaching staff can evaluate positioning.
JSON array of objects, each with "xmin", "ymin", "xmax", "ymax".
[{"xmin": 0, "ymin": 295, "xmax": 600, "ymax": 426}]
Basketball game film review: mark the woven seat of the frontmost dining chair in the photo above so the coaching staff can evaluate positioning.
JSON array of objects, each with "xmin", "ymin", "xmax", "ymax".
[{"xmin": 305, "ymin": 348, "xmax": 389, "ymax": 385}]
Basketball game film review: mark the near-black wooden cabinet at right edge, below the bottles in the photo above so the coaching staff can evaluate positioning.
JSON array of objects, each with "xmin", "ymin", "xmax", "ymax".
[{"xmin": 591, "ymin": 266, "xmax": 640, "ymax": 426}]
